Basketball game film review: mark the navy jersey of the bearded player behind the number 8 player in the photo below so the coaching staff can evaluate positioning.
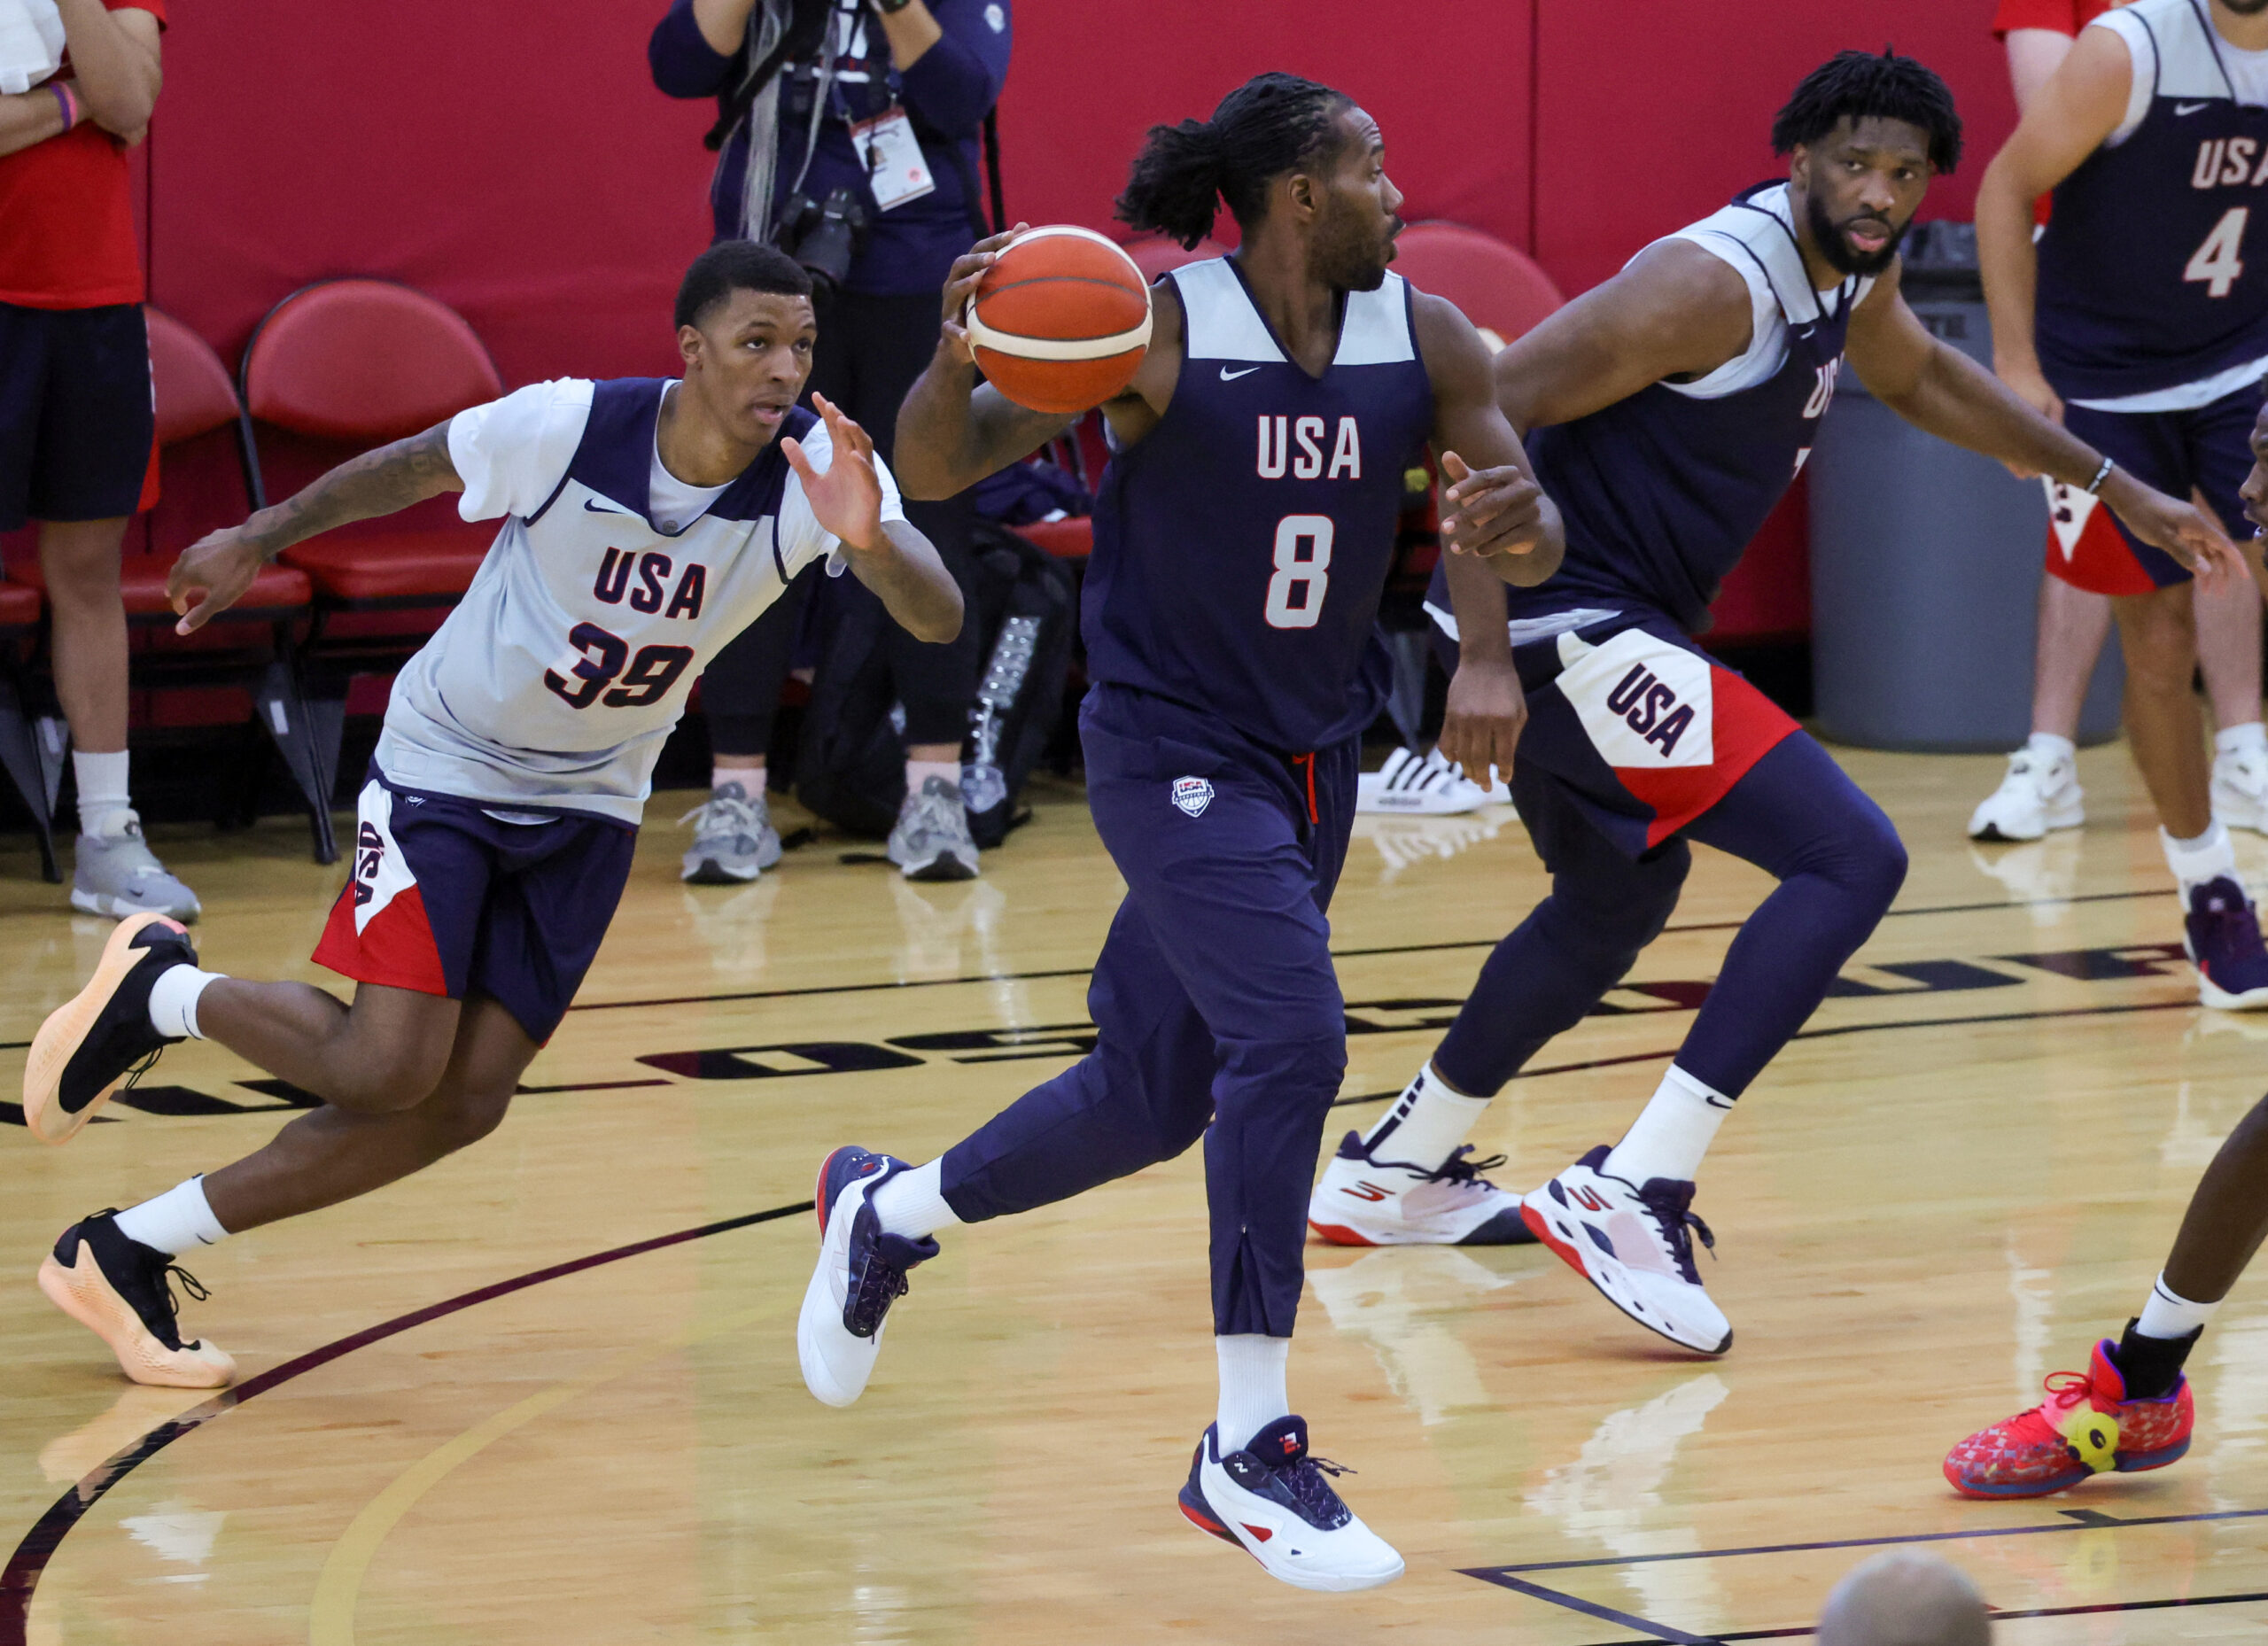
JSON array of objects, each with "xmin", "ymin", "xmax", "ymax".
[{"xmin": 1429, "ymin": 183, "xmax": 1871, "ymax": 633}]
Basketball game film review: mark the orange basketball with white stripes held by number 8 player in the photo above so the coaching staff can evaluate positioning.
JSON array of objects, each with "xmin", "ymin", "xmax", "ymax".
[{"xmin": 968, "ymin": 224, "xmax": 1150, "ymax": 413}]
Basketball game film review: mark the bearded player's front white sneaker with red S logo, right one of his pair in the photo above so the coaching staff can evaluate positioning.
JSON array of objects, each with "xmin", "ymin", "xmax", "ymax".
[{"xmin": 1522, "ymin": 1143, "xmax": 1733, "ymax": 1354}]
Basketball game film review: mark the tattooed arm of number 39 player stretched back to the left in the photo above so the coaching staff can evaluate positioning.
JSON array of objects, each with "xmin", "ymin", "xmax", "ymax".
[{"xmin": 166, "ymin": 419, "xmax": 465, "ymax": 635}]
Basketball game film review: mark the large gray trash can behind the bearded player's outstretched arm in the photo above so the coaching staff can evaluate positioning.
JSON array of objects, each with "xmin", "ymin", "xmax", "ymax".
[{"xmin": 1807, "ymin": 222, "xmax": 2123, "ymax": 750}]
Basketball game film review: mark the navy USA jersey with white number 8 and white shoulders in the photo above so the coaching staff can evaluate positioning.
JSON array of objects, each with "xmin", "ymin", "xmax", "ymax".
[{"xmin": 1080, "ymin": 259, "xmax": 1433, "ymax": 753}]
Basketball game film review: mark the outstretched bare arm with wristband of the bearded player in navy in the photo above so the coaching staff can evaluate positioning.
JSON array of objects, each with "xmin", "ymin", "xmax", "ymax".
[{"xmin": 1848, "ymin": 265, "xmax": 2248, "ymax": 583}]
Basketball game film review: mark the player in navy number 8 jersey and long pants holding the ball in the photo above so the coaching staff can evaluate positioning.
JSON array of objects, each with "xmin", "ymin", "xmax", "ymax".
[{"xmin": 796, "ymin": 74, "xmax": 1558, "ymax": 1589}]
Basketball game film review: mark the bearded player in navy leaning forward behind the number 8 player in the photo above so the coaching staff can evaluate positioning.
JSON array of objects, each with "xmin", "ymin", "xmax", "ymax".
[{"xmin": 1309, "ymin": 52, "xmax": 2241, "ymax": 1354}]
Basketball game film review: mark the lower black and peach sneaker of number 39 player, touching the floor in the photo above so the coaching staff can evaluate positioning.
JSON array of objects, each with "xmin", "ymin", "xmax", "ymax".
[{"xmin": 39, "ymin": 1208, "xmax": 236, "ymax": 1390}]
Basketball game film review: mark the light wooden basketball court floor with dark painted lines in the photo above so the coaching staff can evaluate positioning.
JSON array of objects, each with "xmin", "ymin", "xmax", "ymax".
[{"xmin": 0, "ymin": 749, "xmax": 2268, "ymax": 1646}]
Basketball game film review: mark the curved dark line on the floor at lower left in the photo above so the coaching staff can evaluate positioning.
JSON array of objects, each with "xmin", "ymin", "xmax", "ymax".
[{"xmin": 0, "ymin": 1200, "xmax": 812, "ymax": 1646}]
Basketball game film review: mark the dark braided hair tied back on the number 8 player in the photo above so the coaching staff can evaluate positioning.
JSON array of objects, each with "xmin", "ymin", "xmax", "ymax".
[{"xmin": 1118, "ymin": 73, "xmax": 1354, "ymax": 247}]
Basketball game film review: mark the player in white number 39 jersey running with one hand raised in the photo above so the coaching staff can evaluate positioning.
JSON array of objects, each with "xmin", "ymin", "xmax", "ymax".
[{"xmin": 23, "ymin": 240, "xmax": 961, "ymax": 1387}]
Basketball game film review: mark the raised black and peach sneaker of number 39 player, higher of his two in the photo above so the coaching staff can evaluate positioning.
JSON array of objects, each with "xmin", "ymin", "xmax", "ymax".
[{"xmin": 23, "ymin": 913, "xmax": 198, "ymax": 1143}]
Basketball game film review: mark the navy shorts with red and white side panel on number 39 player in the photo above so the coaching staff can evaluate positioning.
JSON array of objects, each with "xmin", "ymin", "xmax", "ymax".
[{"xmin": 315, "ymin": 764, "xmax": 637, "ymax": 1043}]
